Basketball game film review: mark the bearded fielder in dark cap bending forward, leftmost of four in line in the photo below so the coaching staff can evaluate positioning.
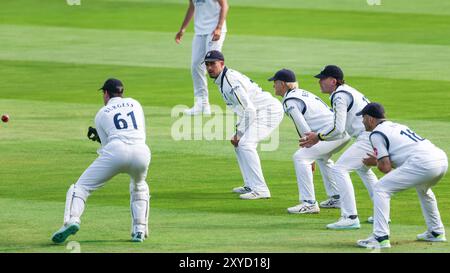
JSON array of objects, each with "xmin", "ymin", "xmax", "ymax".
[{"xmin": 205, "ymin": 50, "xmax": 283, "ymax": 200}]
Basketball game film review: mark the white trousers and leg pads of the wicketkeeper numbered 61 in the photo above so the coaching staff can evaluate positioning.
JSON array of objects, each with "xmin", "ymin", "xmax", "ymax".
[{"xmin": 64, "ymin": 140, "xmax": 151, "ymax": 233}]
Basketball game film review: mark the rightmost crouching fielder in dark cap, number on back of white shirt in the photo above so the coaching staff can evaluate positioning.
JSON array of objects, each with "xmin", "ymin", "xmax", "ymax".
[{"xmin": 357, "ymin": 103, "xmax": 448, "ymax": 248}]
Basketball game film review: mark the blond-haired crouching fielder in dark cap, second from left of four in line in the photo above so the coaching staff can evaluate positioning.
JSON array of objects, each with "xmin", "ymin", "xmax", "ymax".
[{"xmin": 269, "ymin": 69, "xmax": 350, "ymax": 214}]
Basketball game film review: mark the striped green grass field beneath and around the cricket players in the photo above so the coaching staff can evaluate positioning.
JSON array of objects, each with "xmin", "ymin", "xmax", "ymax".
[{"xmin": 0, "ymin": 0, "xmax": 450, "ymax": 253}]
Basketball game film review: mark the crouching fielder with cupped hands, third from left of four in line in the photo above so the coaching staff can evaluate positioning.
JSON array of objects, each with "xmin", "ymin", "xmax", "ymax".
[{"xmin": 300, "ymin": 65, "xmax": 378, "ymax": 229}]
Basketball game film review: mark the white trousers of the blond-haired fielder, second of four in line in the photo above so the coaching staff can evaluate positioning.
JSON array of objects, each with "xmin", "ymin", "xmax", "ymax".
[{"xmin": 293, "ymin": 135, "xmax": 350, "ymax": 203}]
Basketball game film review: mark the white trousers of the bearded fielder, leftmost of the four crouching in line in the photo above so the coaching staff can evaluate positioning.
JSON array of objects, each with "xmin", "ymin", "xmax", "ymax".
[{"xmin": 235, "ymin": 101, "xmax": 284, "ymax": 192}]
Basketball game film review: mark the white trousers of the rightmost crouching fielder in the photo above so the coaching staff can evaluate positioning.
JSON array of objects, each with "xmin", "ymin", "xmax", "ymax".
[{"xmin": 373, "ymin": 149, "xmax": 448, "ymax": 237}]
